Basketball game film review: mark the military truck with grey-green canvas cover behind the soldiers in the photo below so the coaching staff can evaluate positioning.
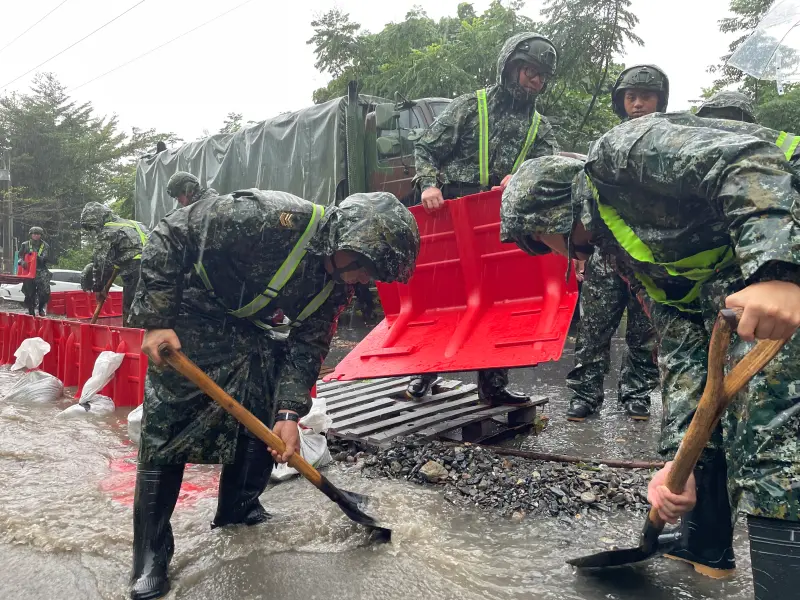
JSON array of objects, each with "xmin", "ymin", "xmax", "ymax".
[{"xmin": 135, "ymin": 82, "xmax": 450, "ymax": 227}]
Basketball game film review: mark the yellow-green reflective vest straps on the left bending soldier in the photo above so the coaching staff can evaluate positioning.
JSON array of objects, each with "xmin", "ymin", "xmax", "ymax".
[{"xmin": 194, "ymin": 204, "xmax": 335, "ymax": 331}]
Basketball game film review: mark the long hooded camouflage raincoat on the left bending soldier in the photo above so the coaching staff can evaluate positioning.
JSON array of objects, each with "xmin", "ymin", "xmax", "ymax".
[{"xmin": 130, "ymin": 189, "xmax": 419, "ymax": 464}]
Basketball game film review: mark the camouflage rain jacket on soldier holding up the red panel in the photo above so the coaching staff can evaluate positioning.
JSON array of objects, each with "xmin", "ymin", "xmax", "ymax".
[{"xmin": 414, "ymin": 33, "xmax": 559, "ymax": 191}]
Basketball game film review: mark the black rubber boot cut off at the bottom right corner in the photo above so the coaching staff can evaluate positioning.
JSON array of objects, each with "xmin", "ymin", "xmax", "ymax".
[{"xmin": 747, "ymin": 515, "xmax": 800, "ymax": 600}]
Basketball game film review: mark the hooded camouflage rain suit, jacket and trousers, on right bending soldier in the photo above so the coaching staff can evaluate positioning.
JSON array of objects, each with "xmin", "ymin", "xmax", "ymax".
[{"xmin": 503, "ymin": 115, "xmax": 800, "ymax": 520}]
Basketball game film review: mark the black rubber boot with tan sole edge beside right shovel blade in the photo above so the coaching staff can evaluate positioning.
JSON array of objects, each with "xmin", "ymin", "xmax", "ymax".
[{"xmin": 665, "ymin": 452, "xmax": 736, "ymax": 579}]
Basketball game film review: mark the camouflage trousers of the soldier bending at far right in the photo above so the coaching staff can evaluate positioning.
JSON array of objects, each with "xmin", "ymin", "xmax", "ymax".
[{"xmin": 648, "ymin": 270, "xmax": 800, "ymax": 521}]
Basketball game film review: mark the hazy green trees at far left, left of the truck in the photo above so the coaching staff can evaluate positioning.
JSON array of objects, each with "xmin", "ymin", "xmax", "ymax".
[{"xmin": 0, "ymin": 73, "xmax": 179, "ymax": 253}]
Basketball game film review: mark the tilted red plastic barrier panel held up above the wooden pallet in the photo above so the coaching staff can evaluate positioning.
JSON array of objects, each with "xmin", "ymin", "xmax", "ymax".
[{"xmin": 325, "ymin": 191, "xmax": 578, "ymax": 381}]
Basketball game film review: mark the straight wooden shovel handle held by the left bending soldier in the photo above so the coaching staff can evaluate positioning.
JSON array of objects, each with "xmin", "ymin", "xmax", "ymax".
[{"xmin": 158, "ymin": 344, "xmax": 322, "ymax": 487}]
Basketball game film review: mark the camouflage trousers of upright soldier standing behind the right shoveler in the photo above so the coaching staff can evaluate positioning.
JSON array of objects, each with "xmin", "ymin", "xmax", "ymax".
[{"xmin": 567, "ymin": 252, "xmax": 658, "ymax": 409}]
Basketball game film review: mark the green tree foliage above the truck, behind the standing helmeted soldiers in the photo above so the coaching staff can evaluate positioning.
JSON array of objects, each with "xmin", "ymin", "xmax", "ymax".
[{"xmin": 308, "ymin": 0, "xmax": 642, "ymax": 150}]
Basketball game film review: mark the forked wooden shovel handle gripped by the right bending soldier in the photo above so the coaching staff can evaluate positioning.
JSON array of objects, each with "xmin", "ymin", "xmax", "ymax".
[{"xmin": 650, "ymin": 309, "xmax": 788, "ymax": 527}]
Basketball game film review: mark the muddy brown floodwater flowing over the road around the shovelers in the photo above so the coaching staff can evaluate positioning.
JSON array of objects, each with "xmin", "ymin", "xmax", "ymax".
[{"xmin": 0, "ymin": 312, "xmax": 752, "ymax": 600}]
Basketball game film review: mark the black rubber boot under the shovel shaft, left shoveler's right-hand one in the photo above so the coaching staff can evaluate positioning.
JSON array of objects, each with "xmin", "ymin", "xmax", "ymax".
[{"xmin": 211, "ymin": 434, "xmax": 274, "ymax": 529}]
